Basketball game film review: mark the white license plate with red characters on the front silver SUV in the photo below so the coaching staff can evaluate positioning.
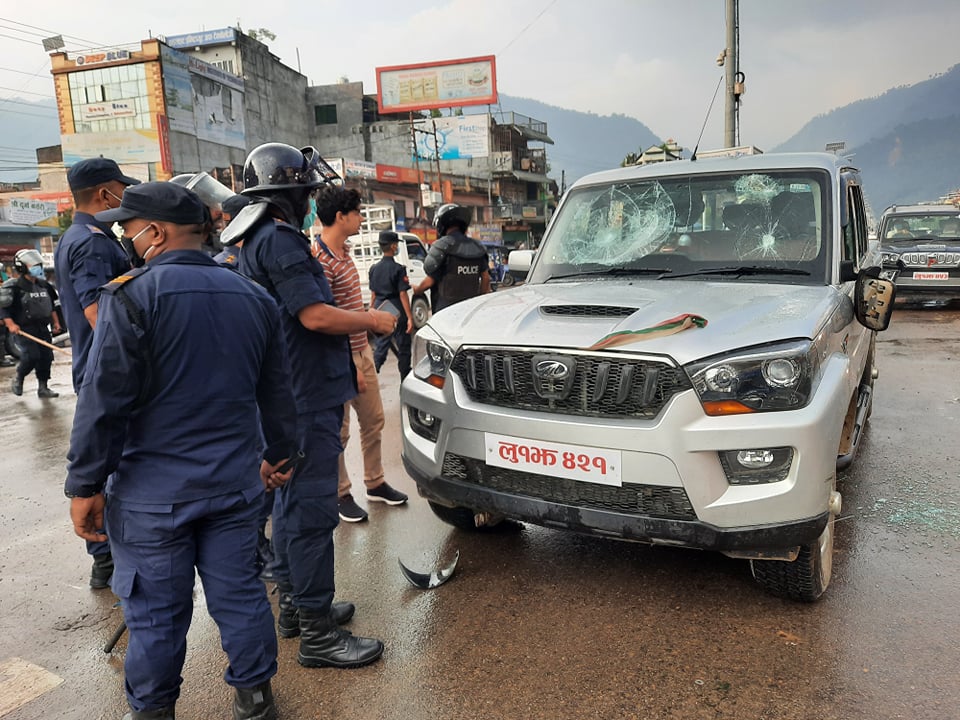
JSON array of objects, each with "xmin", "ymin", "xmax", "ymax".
[{"xmin": 483, "ymin": 433, "xmax": 622, "ymax": 487}]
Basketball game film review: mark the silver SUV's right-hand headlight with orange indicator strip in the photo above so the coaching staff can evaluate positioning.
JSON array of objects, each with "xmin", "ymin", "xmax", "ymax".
[{"xmin": 685, "ymin": 340, "xmax": 820, "ymax": 416}]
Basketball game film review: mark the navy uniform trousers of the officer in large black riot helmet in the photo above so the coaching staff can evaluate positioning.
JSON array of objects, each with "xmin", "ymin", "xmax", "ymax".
[{"xmin": 273, "ymin": 405, "xmax": 343, "ymax": 612}]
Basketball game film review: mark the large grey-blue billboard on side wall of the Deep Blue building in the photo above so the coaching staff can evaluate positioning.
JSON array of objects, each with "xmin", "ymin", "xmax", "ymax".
[{"xmin": 160, "ymin": 45, "xmax": 246, "ymax": 149}]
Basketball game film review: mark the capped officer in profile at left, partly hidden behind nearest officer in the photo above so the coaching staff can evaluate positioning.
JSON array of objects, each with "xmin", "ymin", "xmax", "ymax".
[{"xmin": 53, "ymin": 158, "xmax": 140, "ymax": 590}]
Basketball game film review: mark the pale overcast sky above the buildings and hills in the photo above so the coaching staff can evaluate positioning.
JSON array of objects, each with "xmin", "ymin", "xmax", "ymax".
[{"xmin": 0, "ymin": 0, "xmax": 960, "ymax": 154}]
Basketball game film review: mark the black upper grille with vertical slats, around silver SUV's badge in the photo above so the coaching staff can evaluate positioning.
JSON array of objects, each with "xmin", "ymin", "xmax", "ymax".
[{"xmin": 452, "ymin": 347, "xmax": 691, "ymax": 418}]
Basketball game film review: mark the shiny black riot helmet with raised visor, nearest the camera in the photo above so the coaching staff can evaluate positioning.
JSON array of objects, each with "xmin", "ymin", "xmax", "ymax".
[{"xmin": 242, "ymin": 143, "xmax": 336, "ymax": 195}]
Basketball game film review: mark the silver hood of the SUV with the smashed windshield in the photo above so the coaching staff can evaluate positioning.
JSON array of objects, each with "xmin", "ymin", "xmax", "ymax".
[{"xmin": 430, "ymin": 280, "xmax": 853, "ymax": 365}]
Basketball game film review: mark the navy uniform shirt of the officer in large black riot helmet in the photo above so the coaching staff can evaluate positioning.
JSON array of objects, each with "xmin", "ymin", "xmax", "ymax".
[{"xmin": 240, "ymin": 218, "xmax": 357, "ymax": 413}]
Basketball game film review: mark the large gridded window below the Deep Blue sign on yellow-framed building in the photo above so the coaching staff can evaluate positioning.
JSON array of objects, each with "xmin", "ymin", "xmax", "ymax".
[{"xmin": 69, "ymin": 63, "xmax": 153, "ymax": 133}]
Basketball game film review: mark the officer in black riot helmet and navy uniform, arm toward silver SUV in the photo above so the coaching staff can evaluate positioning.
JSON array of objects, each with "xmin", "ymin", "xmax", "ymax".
[{"xmin": 221, "ymin": 143, "xmax": 395, "ymax": 668}]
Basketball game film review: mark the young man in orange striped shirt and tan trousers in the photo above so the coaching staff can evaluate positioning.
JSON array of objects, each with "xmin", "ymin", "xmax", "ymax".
[{"xmin": 315, "ymin": 186, "xmax": 407, "ymax": 522}]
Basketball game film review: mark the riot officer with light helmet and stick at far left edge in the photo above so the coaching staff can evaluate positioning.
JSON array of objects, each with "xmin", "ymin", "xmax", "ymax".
[{"xmin": 0, "ymin": 250, "xmax": 60, "ymax": 398}]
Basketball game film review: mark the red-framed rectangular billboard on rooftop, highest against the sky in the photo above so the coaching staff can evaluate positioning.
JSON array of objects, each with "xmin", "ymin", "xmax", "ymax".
[{"xmin": 376, "ymin": 55, "xmax": 497, "ymax": 113}]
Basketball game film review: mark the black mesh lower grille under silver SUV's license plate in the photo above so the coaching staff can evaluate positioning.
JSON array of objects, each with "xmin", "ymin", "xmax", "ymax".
[{"xmin": 442, "ymin": 453, "xmax": 697, "ymax": 520}]
